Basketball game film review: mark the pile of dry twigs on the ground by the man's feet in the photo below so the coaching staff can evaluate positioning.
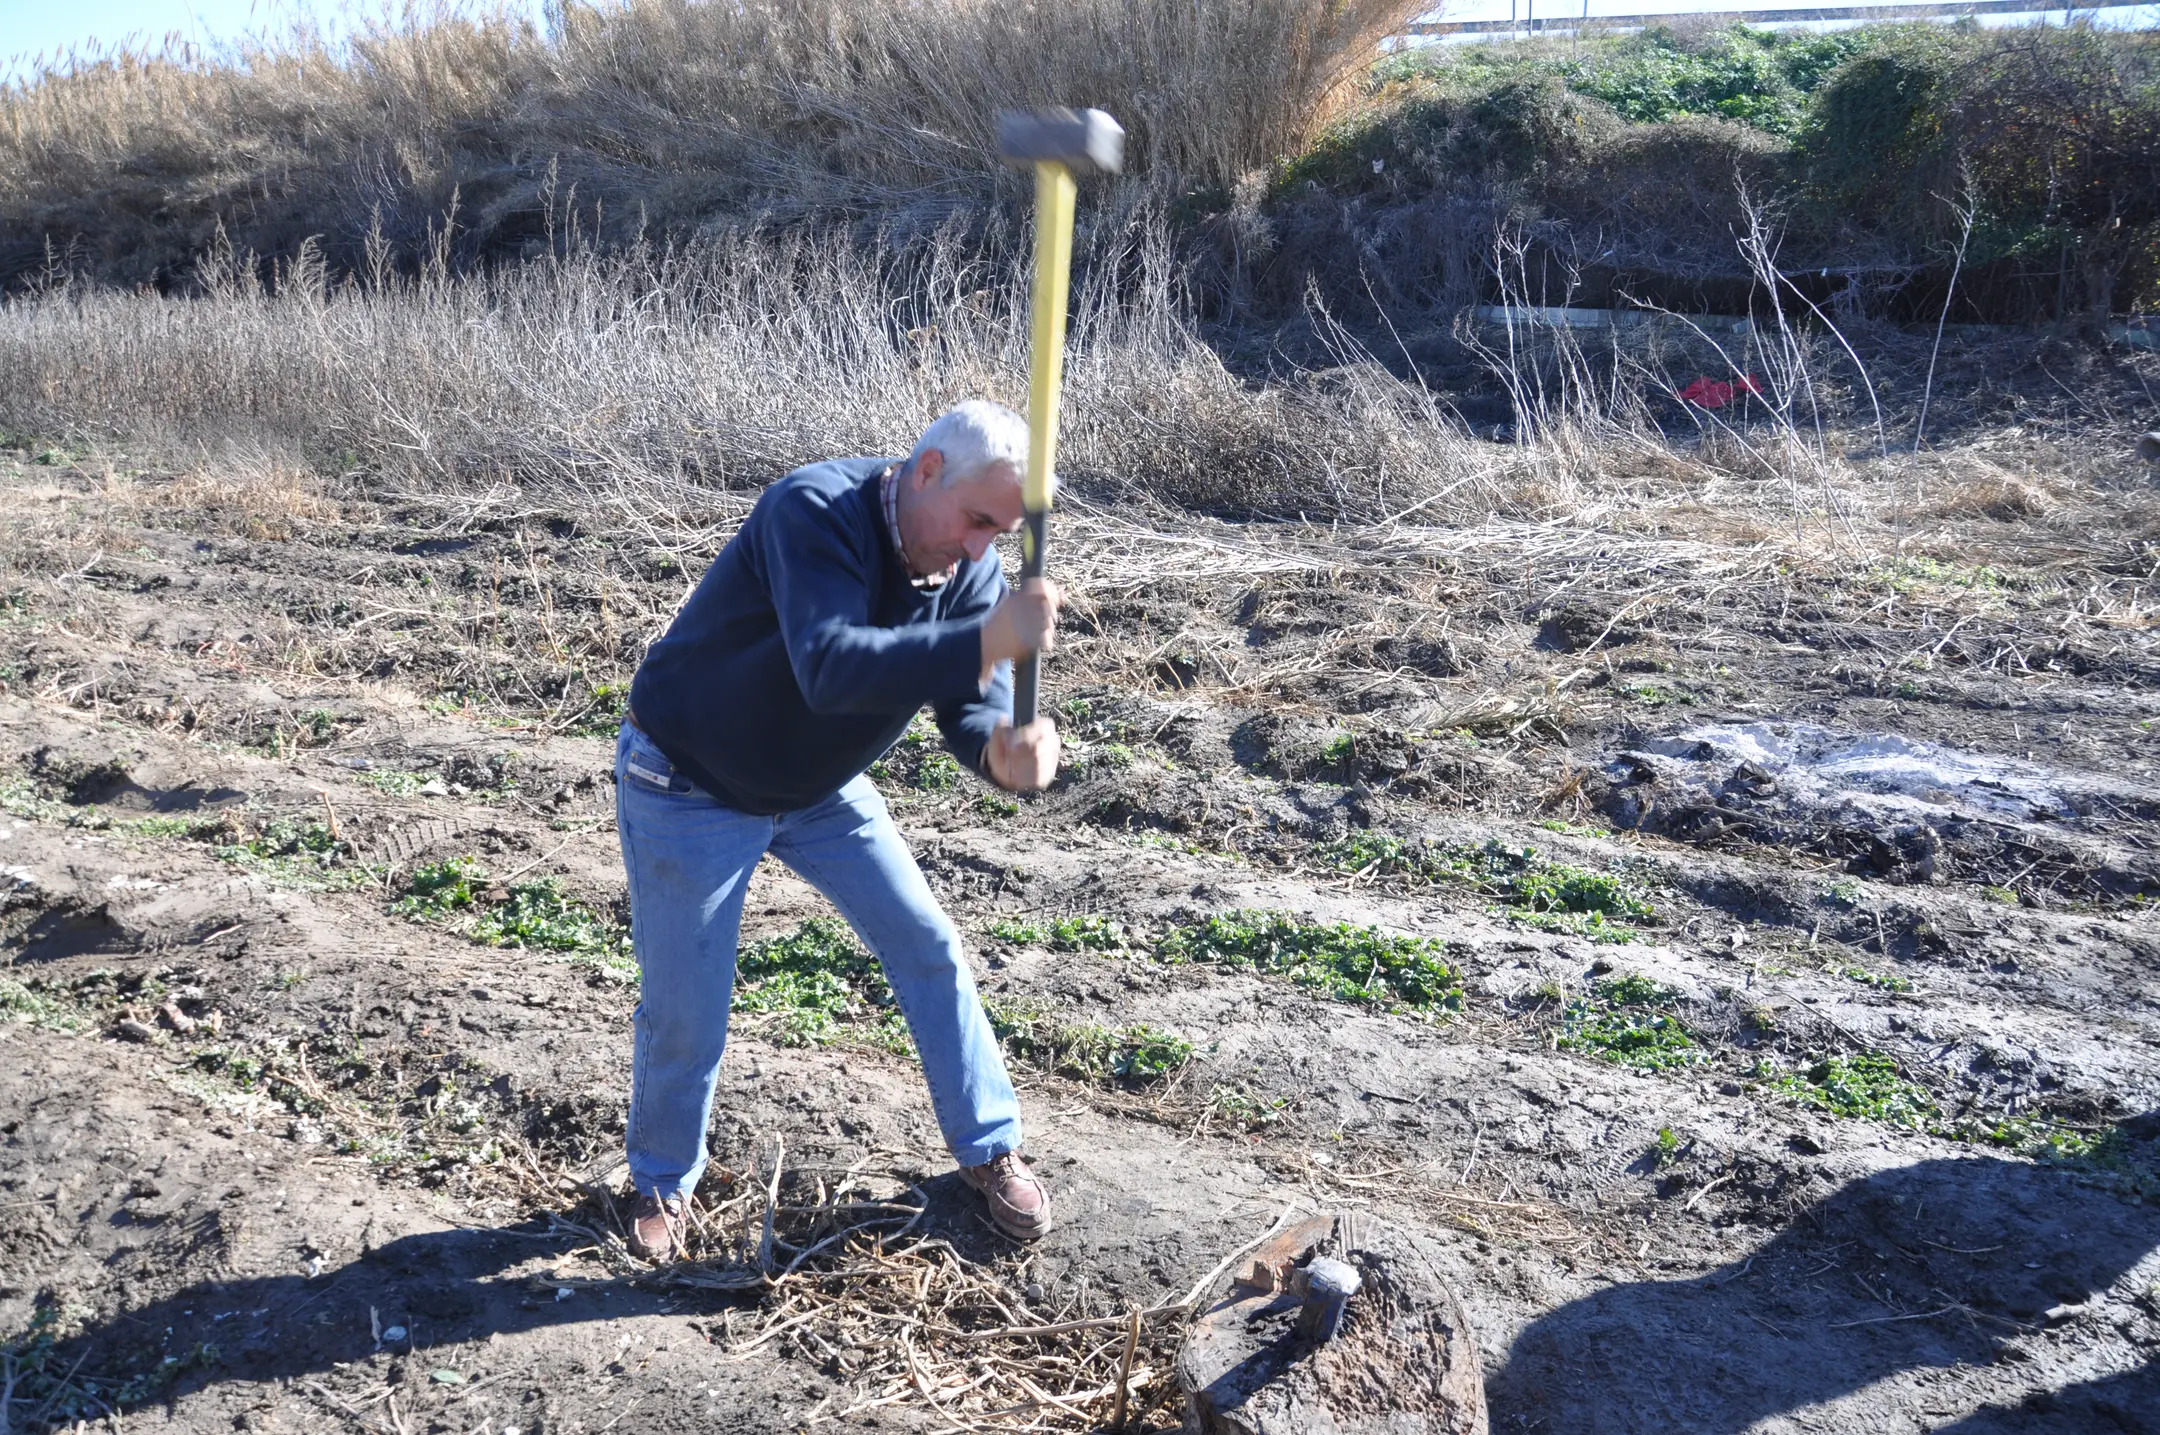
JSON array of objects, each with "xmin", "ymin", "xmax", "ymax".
[{"xmin": 561, "ymin": 1139, "xmax": 1290, "ymax": 1431}]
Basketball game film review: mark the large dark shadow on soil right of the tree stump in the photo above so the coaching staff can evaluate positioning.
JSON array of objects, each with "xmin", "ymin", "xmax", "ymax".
[{"xmin": 1488, "ymin": 1113, "xmax": 2160, "ymax": 1435}]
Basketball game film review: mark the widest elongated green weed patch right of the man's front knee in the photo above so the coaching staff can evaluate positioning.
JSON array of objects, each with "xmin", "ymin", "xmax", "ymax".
[{"xmin": 1153, "ymin": 912, "xmax": 1462, "ymax": 1016}]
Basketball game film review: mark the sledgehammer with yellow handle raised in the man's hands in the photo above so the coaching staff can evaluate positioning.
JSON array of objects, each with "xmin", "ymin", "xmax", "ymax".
[{"xmin": 998, "ymin": 110, "xmax": 1125, "ymax": 726}]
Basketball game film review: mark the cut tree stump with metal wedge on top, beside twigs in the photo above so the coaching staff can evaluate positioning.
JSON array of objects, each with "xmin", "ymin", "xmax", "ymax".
[{"xmin": 1177, "ymin": 1217, "xmax": 1486, "ymax": 1435}]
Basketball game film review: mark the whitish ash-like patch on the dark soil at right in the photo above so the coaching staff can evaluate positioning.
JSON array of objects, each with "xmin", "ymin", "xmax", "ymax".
[{"xmin": 1642, "ymin": 722, "xmax": 2149, "ymax": 823}]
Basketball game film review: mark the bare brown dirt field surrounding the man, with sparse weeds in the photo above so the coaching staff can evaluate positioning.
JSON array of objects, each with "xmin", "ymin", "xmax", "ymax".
[{"xmin": 12, "ymin": 454, "xmax": 2160, "ymax": 1435}]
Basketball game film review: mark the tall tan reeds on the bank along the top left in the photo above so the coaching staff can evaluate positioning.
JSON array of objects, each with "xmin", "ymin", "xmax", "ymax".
[{"xmin": 0, "ymin": 0, "xmax": 1421, "ymax": 281}]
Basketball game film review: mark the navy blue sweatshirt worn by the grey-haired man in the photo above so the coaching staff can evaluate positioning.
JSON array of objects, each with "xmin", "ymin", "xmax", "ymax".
[{"xmin": 631, "ymin": 458, "xmax": 1013, "ymax": 815}]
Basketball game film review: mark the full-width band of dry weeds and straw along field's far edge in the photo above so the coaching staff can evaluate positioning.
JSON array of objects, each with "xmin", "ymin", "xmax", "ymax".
[{"xmin": 0, "ymin": 218, "xmax": 2143, "ymax": 553}]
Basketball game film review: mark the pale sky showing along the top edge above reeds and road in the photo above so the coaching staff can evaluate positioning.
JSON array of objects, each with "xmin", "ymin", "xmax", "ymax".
[{"xmin": 0, "ymin": 0, "xmax": 2160, "ymax": 82}]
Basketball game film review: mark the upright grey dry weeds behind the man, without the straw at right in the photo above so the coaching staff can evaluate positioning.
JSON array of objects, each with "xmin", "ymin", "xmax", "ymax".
[{"xmin": 0, "ymin": 225, "xmax": 1607, "ymax": 525}]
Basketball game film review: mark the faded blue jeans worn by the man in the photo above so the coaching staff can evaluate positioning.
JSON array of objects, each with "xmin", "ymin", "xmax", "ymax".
[{"xmin": 616, "ymin": 724, "xmax": 1020, "ymax": 1197}]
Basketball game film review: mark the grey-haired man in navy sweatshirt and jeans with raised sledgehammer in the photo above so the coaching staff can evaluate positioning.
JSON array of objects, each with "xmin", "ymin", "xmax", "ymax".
[{"xmin": 616, "ymin": 110, "xmax": 1123, "ymax": 1260}]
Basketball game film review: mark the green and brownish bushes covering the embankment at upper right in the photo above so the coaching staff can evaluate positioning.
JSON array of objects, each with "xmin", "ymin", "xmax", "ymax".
[{"xmin": 1274, "ymin": 24, "xmax": 2160, "ymax": 322}]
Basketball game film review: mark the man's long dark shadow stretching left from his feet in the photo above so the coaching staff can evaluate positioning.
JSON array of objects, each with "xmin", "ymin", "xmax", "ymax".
[{"xmin": 0, "ymin": 1174, "xmax": 1011, "ymax": 1431}]
